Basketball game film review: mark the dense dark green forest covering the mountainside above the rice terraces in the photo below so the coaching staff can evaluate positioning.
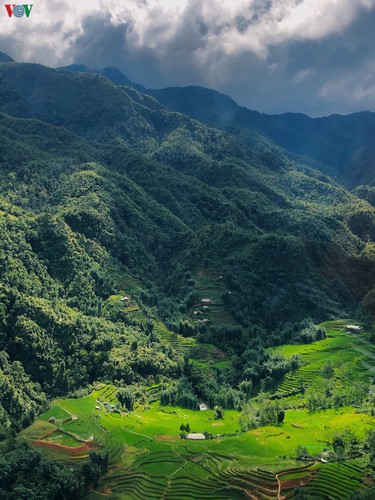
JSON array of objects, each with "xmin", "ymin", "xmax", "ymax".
[{"xmin": 0, "ymin": 54, "xmax": 375, "ymax": 498}]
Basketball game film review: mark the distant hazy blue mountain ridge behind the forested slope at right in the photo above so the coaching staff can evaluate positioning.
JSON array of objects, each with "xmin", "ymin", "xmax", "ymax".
[{"xmin": 147, "ymin": 87, "xmax": 375, "ymax": 186}]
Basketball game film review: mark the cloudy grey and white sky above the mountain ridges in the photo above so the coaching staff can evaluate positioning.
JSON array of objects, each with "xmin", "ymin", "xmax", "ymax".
[{"xmin": 0, "ymin": 0, "xmax": 375, "ymax": 116}]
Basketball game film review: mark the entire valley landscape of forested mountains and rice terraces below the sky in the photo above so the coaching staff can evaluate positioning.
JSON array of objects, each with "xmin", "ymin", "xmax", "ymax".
[{"xmin": 0, "ymin": 54, "xmax": 375, "ymax": 500}]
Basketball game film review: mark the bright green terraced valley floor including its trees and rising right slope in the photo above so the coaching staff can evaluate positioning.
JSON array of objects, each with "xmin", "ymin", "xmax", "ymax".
[{"xmin": 18, "ymin": 322, "xmax": 375, "ymax": 500}]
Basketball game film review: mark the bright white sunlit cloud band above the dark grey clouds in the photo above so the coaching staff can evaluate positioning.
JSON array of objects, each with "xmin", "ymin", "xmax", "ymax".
[{"xmin": 0, "ymin": 0, "xmax": 375, "ymax": 64}]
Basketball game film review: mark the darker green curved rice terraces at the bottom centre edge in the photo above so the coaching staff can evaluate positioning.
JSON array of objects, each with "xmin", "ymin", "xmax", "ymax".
[{"xmin": 102, "ymin": 449, "xmax": 284, "ymax": 500}]
